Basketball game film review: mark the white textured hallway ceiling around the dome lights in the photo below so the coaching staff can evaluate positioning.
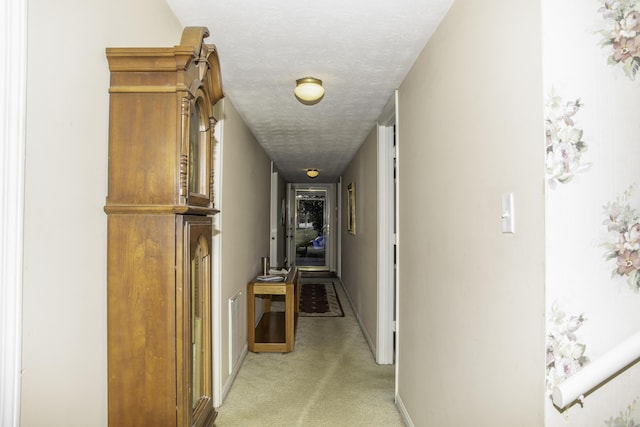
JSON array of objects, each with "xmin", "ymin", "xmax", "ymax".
[{"xmin": 167, "ymin": 0, "xmax": 453, "ymax": 182}]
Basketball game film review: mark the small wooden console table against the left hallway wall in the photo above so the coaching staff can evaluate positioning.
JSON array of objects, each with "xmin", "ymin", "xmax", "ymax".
[{"xmin": 247, "ymin": 267, "xmax": 300, "ymax": 353}]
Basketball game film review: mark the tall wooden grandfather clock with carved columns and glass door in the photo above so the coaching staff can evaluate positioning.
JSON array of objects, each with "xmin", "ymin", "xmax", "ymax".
[{"xmin": 105, "ymin": 27, "xmax": 223, "ymax": 427}]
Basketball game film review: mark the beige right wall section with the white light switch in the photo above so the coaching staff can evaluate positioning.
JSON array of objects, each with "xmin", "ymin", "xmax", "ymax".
[{"xmin": 398, "ymin": 0, "xmax": 545, "ymax": 427}]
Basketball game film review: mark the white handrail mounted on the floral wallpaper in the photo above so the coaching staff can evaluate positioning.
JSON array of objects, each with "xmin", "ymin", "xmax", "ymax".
[{"xmin": 551, "ymin": 332, "xmax": 640, "ymax": 409}]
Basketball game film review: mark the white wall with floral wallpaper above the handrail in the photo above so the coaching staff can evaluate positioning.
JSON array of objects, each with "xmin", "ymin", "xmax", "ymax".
[{"xmin": 541, "ymin": 0, "xmax": 640, "ymax": 427}]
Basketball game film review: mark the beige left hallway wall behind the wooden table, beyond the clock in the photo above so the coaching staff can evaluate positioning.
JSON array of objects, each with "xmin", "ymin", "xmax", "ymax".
[{"xmin": 214, "ymin": 98, "xmax": 271, "ymax": 398}]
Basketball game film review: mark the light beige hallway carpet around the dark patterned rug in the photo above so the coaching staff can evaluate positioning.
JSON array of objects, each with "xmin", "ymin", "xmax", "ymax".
[{"xmin": 215, "ymin": 278, "xmax": 404, "ymax": 427}]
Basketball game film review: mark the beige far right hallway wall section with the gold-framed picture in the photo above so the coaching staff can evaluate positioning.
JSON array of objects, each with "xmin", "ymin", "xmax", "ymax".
[{"xmin": 340, "ymin": 128, "xmax": 378, "ymax": 354}]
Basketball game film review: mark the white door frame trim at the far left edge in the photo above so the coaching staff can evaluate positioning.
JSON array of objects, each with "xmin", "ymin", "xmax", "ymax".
[{"xmin": 0, "ymin": 0, "xmax": 28, "ymax": 427}]
